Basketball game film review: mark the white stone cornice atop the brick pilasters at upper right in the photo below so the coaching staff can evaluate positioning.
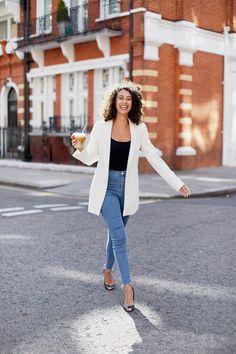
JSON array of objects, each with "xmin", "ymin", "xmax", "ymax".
[{"xmin": 144, "ymin": 11, "xmax": 236, "ymax": 66}]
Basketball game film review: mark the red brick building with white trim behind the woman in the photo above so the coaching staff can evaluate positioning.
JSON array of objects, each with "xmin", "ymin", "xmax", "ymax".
[{"xmin": 0, "ymin": 0, "xmax": 236, "ymax": 171}]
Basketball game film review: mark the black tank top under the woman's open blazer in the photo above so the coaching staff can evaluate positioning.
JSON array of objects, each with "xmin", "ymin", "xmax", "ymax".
[{"xmin": 109, "ymin": 139, "xmax": 130, "ymax": 171}]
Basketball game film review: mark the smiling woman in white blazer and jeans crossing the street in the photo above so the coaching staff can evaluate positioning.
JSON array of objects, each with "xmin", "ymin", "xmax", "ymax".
[{"xmin": 71, "ymin": 82, "xmax": 190, "ymax": 312}]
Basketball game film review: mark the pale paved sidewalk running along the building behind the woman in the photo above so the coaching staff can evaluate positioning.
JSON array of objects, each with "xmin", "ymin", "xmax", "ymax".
[{"xmin": 0, "ymin": 160, "xmax": 236, "ymax": 199}]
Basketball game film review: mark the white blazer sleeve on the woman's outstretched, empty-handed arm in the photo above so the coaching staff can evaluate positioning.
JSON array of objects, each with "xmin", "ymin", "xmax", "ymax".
[{"xmin": 140, "ymin": 123, "xmax": 184, "ymax": 191}]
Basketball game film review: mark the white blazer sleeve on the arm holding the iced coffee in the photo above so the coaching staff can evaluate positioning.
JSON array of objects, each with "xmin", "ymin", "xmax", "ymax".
[{"xmin": 72, "ymin": 122, "xmax": 99, "ymax": 166}]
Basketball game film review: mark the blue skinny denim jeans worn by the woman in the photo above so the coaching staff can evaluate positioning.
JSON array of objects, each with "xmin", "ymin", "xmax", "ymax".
[{"xmin": 101, "ymin": 170, "xmax": 131, "ymax": 285}]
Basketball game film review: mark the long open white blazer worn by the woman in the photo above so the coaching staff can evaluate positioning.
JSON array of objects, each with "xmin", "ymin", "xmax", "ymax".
[{"xmin": 73, "ymin": 120, "xmax": 184, "ymax": 216}]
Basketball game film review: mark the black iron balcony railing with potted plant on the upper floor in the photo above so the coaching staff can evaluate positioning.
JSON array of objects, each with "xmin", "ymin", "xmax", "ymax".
[{"xmin": 18, "ymin": 0, "xmax": 120, "ymax": 48}]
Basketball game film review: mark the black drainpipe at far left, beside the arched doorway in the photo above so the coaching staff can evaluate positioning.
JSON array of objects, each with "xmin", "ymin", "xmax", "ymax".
[{"xmin": 23, "ymin": 0, "xmax": 32, "ymax": 162}]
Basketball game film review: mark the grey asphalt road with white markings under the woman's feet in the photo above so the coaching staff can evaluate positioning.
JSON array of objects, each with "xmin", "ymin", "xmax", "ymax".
[{"xmin": 0, "ymin": 187, "xmax": 236, "ymax": 354}]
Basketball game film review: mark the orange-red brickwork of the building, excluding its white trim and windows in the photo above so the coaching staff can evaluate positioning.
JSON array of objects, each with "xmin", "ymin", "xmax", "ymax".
[{"xmin": 4, "ymin": 0, "xmax": 233, "ymax": 172}]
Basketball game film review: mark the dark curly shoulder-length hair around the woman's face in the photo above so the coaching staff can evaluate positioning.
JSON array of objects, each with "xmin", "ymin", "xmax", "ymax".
[{"xmin": 102, "ymin": 81, "xmax": 143, "ymax": 125}]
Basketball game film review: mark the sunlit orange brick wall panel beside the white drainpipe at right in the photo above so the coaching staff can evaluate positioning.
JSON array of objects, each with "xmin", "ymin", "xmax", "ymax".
[{"xmin": 192, "ymin": 53, "xmax": 223, "ymax": 167}]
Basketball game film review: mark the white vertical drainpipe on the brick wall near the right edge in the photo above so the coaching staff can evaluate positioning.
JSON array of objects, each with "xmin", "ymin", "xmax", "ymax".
[{"xmin": 222, "ymin": 26, "xmax": 230, "ymax": 166}]
